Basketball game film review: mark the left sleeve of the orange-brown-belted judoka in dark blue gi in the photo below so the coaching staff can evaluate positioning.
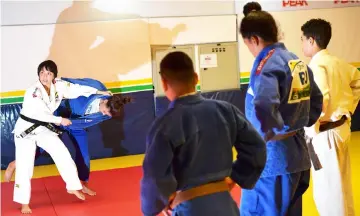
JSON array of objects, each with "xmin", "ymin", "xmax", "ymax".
[{"xmin": 140, "ymin": 124, "xmax": 177, "ymax": 216}]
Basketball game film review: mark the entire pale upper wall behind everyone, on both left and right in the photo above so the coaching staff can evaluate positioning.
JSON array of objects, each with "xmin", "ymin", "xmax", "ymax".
[{"xmin": 1, "ymin": 0, "xmax": 360, "ymax": 92}]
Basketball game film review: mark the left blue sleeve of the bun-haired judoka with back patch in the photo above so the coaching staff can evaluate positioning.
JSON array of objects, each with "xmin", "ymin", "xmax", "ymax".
[{"xmin": 253, "ymin": 70, "xmax": 284, "ymax": 133}]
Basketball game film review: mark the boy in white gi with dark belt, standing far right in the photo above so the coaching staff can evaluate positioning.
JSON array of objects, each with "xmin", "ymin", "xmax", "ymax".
[{"xmin": 301, "ymin": 19, "xmax": 360, "ymax": 216}]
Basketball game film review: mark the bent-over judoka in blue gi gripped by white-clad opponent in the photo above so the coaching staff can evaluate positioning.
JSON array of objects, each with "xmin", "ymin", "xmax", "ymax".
[{"xmin": 5, "ymin": 78, "xmax": 131, "ymax": 196}]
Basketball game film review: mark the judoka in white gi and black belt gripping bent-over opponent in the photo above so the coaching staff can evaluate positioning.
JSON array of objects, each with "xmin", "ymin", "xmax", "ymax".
[{"xmin": 13, "ymin": 60, "xmax": 110, "ymax": 214}]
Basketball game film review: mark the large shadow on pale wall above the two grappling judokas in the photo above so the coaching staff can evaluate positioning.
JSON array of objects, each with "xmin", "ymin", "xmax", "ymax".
[{"xmin": 48, "ymin": 2, "xmax": 186, "ymax": 82}]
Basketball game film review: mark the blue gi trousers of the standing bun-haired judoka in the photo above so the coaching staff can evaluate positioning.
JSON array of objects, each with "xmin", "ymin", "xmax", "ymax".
[{"xmin": 240, "ymin": 170, "xmax": 310, "ymax": 216}]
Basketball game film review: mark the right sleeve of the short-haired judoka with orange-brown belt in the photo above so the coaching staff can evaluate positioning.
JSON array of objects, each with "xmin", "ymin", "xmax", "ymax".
[{"xmin": 230, "ymin": 107, "xmax": 266, "ymax": 189}]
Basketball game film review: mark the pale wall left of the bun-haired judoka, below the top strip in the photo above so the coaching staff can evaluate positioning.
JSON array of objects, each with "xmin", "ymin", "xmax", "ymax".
[{"xmin": 1, "ymin": 15, "xmax": 237, "ymax": 92}]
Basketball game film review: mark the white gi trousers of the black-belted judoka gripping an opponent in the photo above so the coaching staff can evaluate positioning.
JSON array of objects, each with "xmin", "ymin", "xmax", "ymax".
[{"xmin": 13, "ymin": 132, "xmax": 82, "ymax": 204}]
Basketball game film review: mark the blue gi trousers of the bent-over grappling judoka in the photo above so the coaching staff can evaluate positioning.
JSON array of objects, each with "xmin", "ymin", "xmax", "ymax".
[{"xmin": 35, "ymin": 130, "xmax": 90, "ymax": 182}]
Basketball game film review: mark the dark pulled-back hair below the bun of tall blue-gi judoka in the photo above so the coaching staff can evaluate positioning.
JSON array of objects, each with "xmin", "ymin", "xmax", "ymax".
[{"xmin": 240, "ymin": 11, "xmax": 278, "ymax": 43}]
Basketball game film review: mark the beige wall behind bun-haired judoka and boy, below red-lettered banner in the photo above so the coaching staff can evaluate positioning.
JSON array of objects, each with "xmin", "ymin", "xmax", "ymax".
[{"xmin": 238, "ymin": 7, "xmax": 360, "ymax": 72}]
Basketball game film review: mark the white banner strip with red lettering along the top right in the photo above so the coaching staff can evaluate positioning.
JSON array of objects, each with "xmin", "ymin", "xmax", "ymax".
[{"xmin": 235, "ymin": 0, "xmax": 360, "ymax": 14}]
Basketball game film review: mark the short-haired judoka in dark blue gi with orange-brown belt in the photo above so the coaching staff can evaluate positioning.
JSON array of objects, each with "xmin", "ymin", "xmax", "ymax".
[{"xmin": 141, "ymin": 52, "xmax": 266, "ymax": 216}]
